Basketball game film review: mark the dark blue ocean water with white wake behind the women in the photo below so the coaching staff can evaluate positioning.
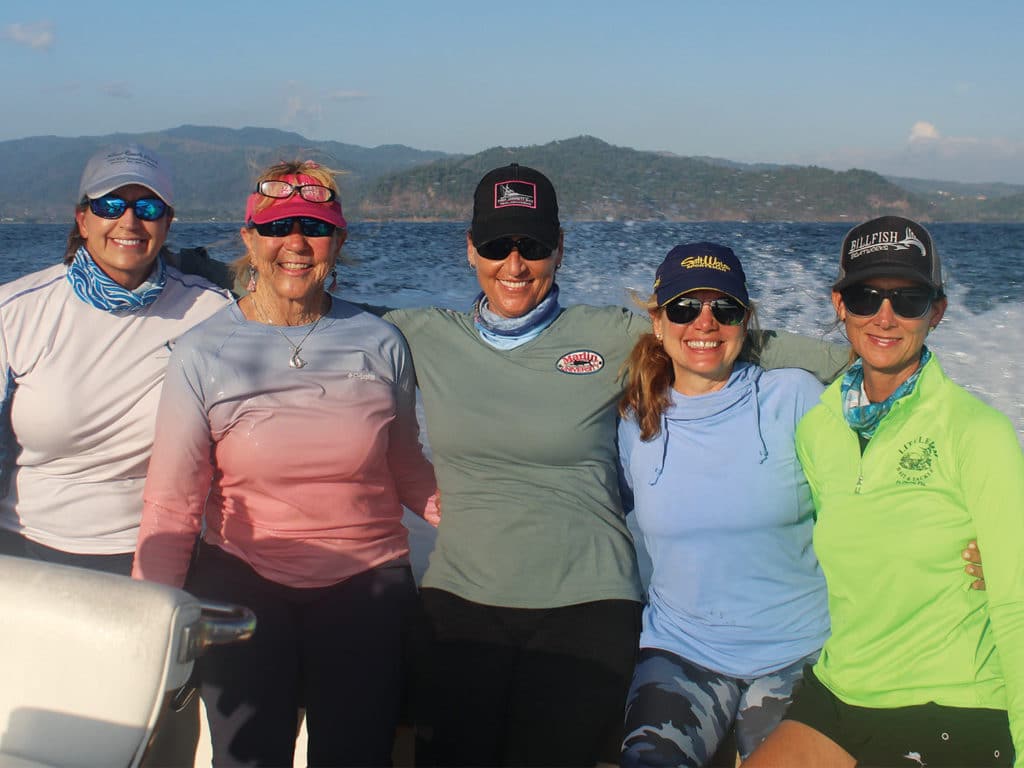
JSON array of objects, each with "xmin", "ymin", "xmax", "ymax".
[{"xmin": 0, "ymin": 225, "xmax": 1024, "ymax": 571}]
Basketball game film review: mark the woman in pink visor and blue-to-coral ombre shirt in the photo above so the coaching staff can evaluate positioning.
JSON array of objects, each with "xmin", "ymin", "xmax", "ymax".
[{"xmin": 134, "ymin": 162, "xmax": 436, "ymax": 766}]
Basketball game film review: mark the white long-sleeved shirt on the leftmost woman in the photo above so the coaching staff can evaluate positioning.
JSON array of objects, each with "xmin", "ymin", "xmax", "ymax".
[{"xmin": 0, "ymin": 264, "xmax": 229, "ymax": 555}]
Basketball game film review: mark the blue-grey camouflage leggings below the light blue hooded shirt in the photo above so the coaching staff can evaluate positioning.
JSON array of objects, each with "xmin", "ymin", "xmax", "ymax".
[{"xmin": 622, "ymin": 648, "xmax": 818, "ymax": 768}]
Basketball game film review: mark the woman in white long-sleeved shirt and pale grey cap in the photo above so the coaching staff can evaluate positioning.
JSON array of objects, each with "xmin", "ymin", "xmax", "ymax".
[{"xmin": 0, "ymin": 144, "xmax": 228, "ymax": 765}]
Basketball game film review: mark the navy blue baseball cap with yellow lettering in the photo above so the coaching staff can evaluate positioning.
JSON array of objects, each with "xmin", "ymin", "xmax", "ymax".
[{"xmin": 654, "ymin": 243, "xmax": 751, "ymax": 306}]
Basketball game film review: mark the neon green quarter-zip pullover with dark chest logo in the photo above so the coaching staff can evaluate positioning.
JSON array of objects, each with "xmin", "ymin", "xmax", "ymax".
[{"xmin": 797, "ymin": 355, "xmax": 1024, "ymax": 755}]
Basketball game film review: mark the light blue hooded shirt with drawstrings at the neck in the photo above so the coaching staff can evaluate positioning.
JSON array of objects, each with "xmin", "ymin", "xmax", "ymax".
[{"xmin": 618, "ymin": 362, "xmax": 828, "ymax": 679}]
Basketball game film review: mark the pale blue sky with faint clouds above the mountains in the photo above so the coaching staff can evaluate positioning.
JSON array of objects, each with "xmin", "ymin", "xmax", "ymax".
[{"xmin": 0, "ymin": 0, "xmax": 1024, "ymax": 183}]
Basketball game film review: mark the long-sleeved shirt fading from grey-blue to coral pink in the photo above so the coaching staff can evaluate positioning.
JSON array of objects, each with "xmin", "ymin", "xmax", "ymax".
[{"xmin": 133, "ymin": 298, "xmax": 436, "ymax": 587}]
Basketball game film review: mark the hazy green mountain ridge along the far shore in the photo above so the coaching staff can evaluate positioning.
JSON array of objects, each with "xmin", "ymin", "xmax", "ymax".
[{"xmin": 0, "ymin": 125, "xmax": 1024, "ymax": 222}]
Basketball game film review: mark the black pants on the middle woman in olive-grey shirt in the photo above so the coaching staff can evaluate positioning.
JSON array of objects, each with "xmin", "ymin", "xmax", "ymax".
[{"xmin": 416, "ymin": 589, "xmax": 641, "ymax": 766}]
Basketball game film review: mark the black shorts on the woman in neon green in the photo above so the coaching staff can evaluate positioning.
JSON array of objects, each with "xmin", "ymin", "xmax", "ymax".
[{"xmin": 783, "ymin": 667, "xmax": 1014, "ymax": 768}]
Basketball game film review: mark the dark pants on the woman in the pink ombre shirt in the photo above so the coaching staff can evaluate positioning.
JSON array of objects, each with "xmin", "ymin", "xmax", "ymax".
[{"xmin": 185, "ymin": 544, "xmax": 416, "ymax": 766}]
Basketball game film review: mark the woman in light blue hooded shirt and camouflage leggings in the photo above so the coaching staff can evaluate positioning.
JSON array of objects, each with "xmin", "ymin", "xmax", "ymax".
[{"xmin": 618, "ymin": 243, "xmax": 828, "ymax": 766}]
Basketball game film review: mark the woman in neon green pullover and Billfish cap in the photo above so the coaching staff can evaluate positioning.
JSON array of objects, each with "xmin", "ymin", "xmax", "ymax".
[{"xmin": 748, "ymin": 216, "xmax": 1024, "ymax": 768}]
